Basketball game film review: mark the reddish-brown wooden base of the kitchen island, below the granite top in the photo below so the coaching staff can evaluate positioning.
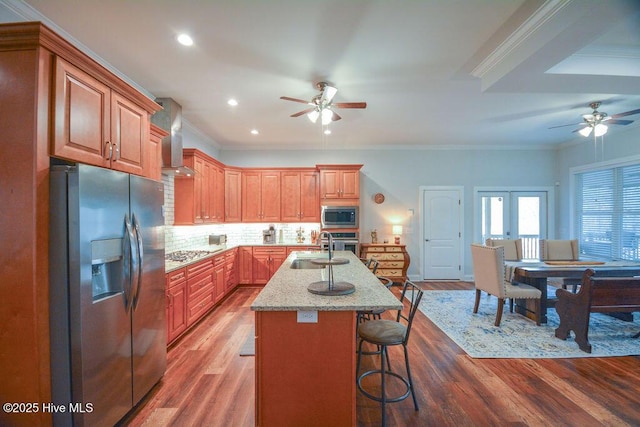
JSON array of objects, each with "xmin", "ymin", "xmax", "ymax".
[{"xmin": 256, "ymin": 311, "xmax": 356, "ymax": 427}]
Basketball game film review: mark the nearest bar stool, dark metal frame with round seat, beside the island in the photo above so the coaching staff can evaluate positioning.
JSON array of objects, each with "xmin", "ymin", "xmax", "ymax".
[{"xmin": 356, "ymin": 280, "xmax": 423, "ymax": 426}]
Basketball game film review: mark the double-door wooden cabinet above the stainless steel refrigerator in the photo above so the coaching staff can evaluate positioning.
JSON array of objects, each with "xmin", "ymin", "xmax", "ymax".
[{"xmin": 52, "ymin": 57, "xmax": 150, "ymax": 175}]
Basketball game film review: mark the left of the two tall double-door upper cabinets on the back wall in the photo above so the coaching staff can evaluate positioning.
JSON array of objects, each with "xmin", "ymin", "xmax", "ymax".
[{"xmin": 242, "ymin": 170, "xmax": 281, "ymax": 222}]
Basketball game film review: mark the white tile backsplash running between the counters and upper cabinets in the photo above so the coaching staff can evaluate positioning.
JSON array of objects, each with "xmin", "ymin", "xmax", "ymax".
[{"xmin": 162, "ymin": 175, "xmax": 320, "ymax": 253}]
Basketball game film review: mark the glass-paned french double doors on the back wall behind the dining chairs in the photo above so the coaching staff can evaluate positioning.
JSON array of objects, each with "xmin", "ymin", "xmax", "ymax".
[{"xmin": 476, "ymin": 191, "xmax": 548, "ymax": 258}]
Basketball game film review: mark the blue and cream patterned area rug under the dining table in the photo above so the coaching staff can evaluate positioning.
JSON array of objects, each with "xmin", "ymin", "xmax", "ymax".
[{"xmin": 419, "ymin": 290, "xmax": 640, "ymax": 358}]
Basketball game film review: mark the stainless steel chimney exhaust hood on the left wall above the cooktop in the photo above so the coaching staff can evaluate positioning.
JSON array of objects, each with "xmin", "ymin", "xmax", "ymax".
[{"xmin": 151, "ymin": 98, "xmax": 195, "ymax": 176}]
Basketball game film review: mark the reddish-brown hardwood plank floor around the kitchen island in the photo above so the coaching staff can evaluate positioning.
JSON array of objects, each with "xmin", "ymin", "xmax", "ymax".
[{"xmin": 122, "ymin": 282, "xmax": 640, "ymax": 426}]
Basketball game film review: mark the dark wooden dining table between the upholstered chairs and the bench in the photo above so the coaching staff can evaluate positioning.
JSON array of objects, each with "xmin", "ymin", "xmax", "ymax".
[{"xmin": 505, "ymin": 259, "xmax": 640, "ymax": 323}]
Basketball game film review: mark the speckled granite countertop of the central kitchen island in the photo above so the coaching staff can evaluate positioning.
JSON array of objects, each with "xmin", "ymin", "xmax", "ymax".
[{"xmin": 251, "ymin": 251, "xmax": 402, "ymax": 311}]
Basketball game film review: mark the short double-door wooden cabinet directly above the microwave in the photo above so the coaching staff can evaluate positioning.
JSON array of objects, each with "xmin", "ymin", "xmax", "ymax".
[{"xmin": 317, "ymin": 165, "xmax": 362, "ymax": 199}]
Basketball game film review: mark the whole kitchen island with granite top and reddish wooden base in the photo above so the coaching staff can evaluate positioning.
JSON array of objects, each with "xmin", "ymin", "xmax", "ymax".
[{"xmin": 251, "ymin": 251, "xmax": 402, "ymax": 426}]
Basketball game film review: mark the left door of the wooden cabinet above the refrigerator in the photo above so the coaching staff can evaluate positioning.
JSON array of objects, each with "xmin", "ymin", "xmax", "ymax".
[{"xmin": 53, "ymin": 58, "xmax": 111, "ymax": 167}]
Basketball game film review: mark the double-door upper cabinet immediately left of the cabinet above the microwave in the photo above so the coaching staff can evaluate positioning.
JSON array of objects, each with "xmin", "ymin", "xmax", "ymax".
[{"xmin": 281, "ymin": 170, "xmax": 320, "ymax": 222}]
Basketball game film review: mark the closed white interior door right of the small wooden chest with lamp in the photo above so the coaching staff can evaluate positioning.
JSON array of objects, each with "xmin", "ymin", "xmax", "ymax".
[{"xmin": 422, "ymin": 188, "xmax": 462, "ymax": 280}]
